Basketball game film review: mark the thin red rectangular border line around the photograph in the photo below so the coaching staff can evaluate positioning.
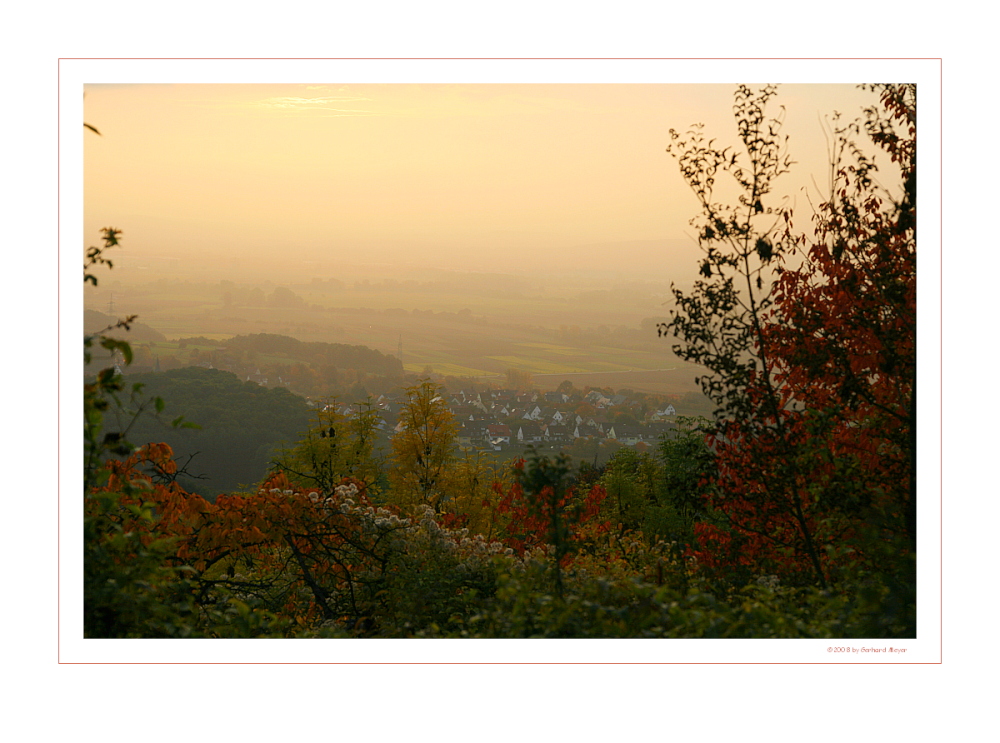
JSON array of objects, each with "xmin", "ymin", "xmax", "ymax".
[{"xmin": 56, "ymin": 57, "xmax": 944, "ymax": 666}]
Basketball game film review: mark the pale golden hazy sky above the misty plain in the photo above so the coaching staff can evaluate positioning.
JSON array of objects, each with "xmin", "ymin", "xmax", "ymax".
[{"xmin": 84, "ymin": 83, "xmax": 871, "ymax": 280}]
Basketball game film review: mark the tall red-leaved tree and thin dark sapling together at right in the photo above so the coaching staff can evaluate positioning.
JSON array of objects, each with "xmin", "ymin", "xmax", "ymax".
[{"xmin": 660, "ymin": 85, "xmax": 916, "ymax": 595}]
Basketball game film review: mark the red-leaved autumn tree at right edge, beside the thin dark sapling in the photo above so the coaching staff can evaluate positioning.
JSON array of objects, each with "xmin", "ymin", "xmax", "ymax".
[{"xmin": 674, "ymin": 86, "xmax": 916, "ymax": 584}]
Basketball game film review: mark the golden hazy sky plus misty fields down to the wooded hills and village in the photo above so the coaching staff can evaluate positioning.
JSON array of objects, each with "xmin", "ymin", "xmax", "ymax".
[{"xmin": 84, "ymin": 82, "xmax": 884, "ymax": 392}]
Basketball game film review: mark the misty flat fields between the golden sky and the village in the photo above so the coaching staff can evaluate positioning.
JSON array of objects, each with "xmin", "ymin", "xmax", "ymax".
[{"xmin": 85, "ymin": 262, "xmax": 698, "ymax": 395}]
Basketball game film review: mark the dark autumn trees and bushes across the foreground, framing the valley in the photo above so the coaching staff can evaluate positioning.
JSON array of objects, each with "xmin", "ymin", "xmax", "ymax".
[{"xmin": 83, "ymin": 84, "xmax": 917, "ymax": 639}]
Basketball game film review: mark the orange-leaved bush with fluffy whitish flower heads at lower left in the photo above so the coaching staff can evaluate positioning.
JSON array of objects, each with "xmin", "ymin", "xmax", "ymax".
[{"xmin": 91, "ymin": 446, "xmax": 528, "ymax": 635}]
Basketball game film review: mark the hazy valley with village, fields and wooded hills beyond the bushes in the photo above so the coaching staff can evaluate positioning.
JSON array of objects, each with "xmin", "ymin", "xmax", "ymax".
[{"xmin": 84, "ymin": 268, "xmax": 711, "ymax": 499}]
